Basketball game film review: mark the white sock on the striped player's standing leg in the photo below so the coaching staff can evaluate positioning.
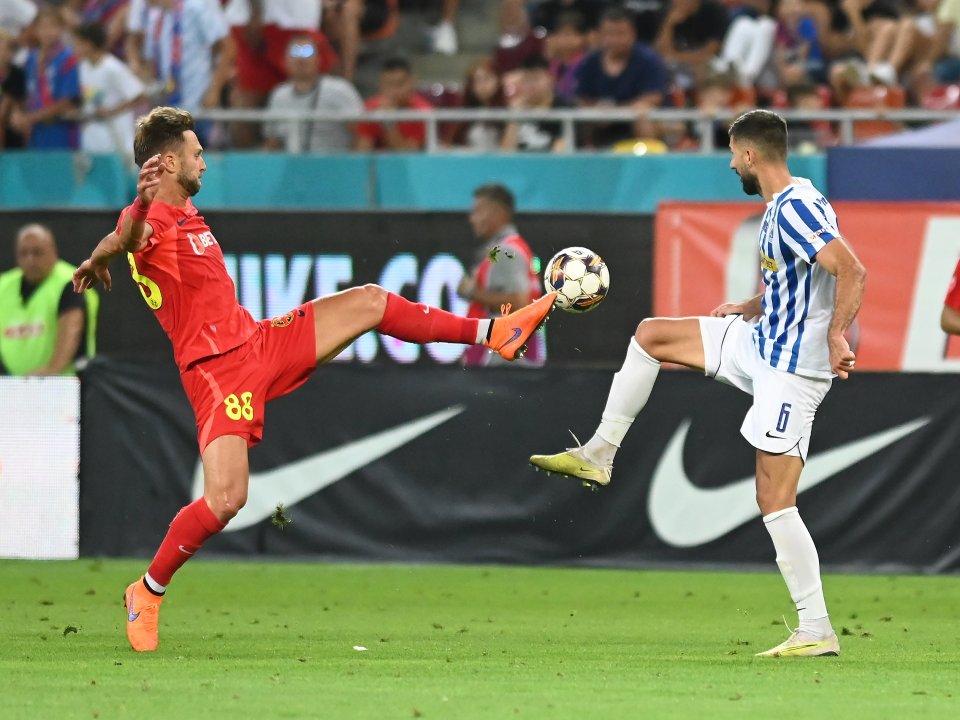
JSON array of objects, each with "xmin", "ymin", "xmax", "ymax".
[{"xmin": 763, "ymin": 507, "xmax": 833, "ymax": 639}]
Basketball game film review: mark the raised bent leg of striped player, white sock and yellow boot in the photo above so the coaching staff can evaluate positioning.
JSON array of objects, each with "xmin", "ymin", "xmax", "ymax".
[{"xmin": 530, "ymin": 318, "xmax": 704, "ymax": 485}]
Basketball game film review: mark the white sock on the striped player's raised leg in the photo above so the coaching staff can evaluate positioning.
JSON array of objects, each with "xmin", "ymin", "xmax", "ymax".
[{"xmin": 584, "ymin": 337, "xmax": 660, "ymax": 465}]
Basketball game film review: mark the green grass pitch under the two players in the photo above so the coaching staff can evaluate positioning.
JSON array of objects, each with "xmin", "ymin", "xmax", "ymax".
[{"xmin": 0, "ymin": 560, "xmax": 960, "ymax": 720}]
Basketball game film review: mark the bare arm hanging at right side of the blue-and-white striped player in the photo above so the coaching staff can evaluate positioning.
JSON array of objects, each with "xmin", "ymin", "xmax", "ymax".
[{"xmin": 816, "ymin": 237, "xmax": 867, "ymax": 380}]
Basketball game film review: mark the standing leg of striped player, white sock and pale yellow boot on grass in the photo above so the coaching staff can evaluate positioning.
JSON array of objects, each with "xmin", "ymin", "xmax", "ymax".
[{"xmin": 757, "ymin": 450, "xmax": 840, "ymax": 657}]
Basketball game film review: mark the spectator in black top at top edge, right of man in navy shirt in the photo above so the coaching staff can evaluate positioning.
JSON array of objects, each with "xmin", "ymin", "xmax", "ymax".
[{"xmin": 654, "ymin": 0, "xmax": 727, "ymax": 90}]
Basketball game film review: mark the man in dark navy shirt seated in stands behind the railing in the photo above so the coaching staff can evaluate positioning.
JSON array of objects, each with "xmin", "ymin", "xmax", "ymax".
[{"xmin": 577, "ymin": 7, "xmax": 669, "ymax": 147}]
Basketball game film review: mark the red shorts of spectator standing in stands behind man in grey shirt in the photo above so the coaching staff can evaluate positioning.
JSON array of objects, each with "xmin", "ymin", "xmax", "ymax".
[{"xmin": 230, "ymin": 25, "xmax": 337, "ymax": 95}]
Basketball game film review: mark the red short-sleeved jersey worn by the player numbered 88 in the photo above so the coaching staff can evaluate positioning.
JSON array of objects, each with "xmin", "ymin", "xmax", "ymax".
[{"xmin": 117, "ymin": 199, "xmax": 257, "ymax": 372}]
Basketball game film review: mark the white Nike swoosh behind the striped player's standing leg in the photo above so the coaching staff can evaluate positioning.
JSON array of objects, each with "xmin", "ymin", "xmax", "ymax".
[{"xmin": 647, "ymin": 418, "xmax": 930, "ymax": 547}]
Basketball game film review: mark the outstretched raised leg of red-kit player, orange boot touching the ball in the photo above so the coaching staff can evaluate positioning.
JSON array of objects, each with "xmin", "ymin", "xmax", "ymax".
[{"xmin": 313, "ymin": 285, "xmax": 556, "ymax": 363}]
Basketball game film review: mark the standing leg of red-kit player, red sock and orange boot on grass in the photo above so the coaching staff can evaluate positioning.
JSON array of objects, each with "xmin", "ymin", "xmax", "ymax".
[{"xmin": 124, "ymin": 435, "xmax": 249, "ymax": 652}]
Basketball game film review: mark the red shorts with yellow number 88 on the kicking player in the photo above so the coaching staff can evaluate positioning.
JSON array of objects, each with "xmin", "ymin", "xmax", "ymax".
[{"xmin": 180, "ymin": 303, "xmax": 317, "ymax": 453}]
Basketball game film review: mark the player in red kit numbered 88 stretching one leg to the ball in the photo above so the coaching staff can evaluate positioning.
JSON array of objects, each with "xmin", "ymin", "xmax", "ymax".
[{"xmin": 74, "ymin": 107, "xmax": 556, "ymax": 651}]
